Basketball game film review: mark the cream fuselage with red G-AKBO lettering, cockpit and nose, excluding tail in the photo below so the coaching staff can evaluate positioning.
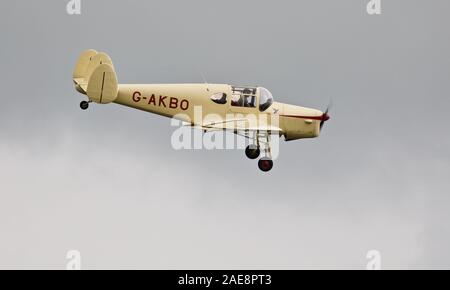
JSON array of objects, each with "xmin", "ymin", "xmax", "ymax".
[{"xmin": 113, "ymin": 84, "xmax": 323, "ymax": 140}]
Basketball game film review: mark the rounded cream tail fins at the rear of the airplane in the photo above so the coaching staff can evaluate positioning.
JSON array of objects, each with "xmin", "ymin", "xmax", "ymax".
[{"xmin": 73, "ymin": 49, "xmax": 118, "ymax": 104}]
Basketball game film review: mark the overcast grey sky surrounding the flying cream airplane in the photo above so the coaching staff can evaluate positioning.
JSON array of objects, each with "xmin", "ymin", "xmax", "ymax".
[{"xmin": 0, "ymin": 0, "xmax": 450, "ymax": 269}]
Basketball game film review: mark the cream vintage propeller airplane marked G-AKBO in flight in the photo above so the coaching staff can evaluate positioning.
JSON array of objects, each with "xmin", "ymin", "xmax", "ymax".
[{"xmin": 73, "ymin": 49, "xmax": 330, "ymax": 172}]
